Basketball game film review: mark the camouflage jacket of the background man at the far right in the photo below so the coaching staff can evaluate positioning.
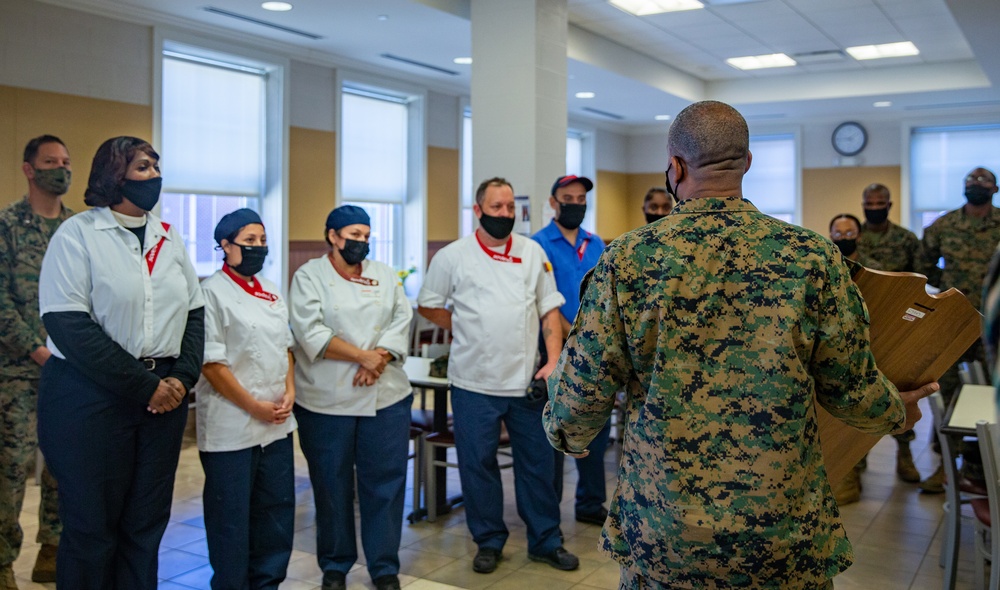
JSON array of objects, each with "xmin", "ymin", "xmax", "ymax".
[{"xmin": 917, "ymin": 207, "xmax": 1000, "ymax": 309}]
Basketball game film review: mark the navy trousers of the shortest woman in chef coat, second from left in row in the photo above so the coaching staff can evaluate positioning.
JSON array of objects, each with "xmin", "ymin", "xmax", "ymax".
[{"xmin": 199, "ymin": 434, "xmax": 295, "ymax": 590}]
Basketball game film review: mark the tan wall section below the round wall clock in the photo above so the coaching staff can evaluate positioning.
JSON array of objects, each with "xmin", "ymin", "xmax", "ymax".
[{"xmin": 800, "ymin": 166, "xmax": 901, "ymax": 236}]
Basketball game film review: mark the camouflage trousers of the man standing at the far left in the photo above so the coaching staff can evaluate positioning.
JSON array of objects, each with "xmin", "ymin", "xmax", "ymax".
[{"xmin": 0, "ymin": 378, "xmax": 62, "ymax": 565}]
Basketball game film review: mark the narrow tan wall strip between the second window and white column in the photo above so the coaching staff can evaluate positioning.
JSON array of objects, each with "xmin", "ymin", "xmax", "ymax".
[{"xmin": 426, "ymin": 146, "xmax": 460, "ymax": 242}]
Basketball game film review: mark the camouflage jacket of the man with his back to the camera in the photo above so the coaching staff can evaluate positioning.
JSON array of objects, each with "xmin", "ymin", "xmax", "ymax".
[{"xmin": 543, "ymin": 197, "xmax": 905, "ymax": 589}]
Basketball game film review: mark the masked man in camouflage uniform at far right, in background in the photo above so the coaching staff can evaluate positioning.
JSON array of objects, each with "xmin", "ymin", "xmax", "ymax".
[{"xmin": 916, "ymin": 168, "xmax": 1000, "ymax": 493}]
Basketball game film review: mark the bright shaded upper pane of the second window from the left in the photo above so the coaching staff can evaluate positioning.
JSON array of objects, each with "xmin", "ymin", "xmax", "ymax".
[{"xmin": 341, "ymin": 92, "xmax": 408, "ymax": 204}]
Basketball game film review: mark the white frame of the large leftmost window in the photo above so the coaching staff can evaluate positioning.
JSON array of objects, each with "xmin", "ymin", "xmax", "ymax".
[{"xmin": 152, "ymin": 27, "xmax": 291, "ymax": 292}]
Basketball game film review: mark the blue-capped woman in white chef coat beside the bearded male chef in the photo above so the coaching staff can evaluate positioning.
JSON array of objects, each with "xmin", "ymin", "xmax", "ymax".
[{"xmin": 289, "ymin": 205, "xmax": 413, "ymax": 590}]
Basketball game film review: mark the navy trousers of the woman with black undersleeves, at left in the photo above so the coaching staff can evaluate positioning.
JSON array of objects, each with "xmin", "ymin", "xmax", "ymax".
[{"xmin": 38, "ymin": 357, "xmax": 188, "ymax": 590}]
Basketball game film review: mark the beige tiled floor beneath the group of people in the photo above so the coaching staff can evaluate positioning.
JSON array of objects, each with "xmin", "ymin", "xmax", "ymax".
[{"xmin": 7, "ymin": 398, "xmax": 992, "ymax": 590}]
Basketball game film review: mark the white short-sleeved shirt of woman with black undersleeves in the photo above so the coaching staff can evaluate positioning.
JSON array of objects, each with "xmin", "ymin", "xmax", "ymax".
[{"xmin": 38, "ymin": 207, "xmax": 205, "ymax": 358}]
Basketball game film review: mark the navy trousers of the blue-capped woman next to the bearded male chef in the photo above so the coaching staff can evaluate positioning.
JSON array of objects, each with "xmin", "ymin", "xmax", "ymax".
[{"xmin": 295, "ymin": 395, "xmax": 413, "ymax": 580}]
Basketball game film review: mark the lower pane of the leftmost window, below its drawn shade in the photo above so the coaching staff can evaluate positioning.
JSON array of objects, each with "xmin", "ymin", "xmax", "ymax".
[{"xmin": 160, "ymin": 192, "xmax": 260, "ymax": 277}]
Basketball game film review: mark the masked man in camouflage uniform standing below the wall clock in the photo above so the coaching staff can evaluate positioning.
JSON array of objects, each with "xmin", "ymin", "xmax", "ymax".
[{"xmin": 858, "ymin": 183, "xmax": 920, "ymax": 483}]
